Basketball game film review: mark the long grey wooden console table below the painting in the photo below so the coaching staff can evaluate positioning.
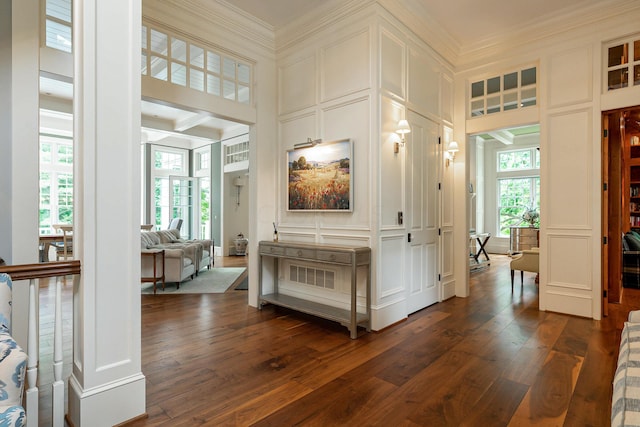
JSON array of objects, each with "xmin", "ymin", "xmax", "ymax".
[{"xmin": 258, "ymin": 241, "xmax": 371, "ymax": 339}]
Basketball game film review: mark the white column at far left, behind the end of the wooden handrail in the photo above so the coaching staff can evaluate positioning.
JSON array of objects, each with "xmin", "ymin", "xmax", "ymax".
[{"xmin": 9, "ymin": 0, "xmax": 40, "ymax": 347}]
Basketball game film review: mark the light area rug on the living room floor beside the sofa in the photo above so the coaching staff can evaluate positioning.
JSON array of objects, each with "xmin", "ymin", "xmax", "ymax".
[{"xmin": 142, "ymin": 267, "xmax": 246, "ymax": 295}]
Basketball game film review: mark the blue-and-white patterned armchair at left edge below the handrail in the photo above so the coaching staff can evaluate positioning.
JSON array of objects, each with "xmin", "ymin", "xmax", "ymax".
[{"xmin": 0, "ymin": 273, "xmax": 28, "ymax": 426}]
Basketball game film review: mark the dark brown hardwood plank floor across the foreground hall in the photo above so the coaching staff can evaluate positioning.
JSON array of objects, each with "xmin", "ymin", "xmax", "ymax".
[{"xmin": 33, "ymin": 255, "xmax": 640, "ymax": 427}]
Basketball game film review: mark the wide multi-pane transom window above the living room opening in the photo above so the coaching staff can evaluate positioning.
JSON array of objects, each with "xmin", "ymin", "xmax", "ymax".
[{"xmin": 141, "ymin": 23, "xmax": 253, "ymax": 104}]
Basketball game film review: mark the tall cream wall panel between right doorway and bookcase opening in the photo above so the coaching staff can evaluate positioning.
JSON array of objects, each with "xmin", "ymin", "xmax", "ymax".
[{"xmin": 540, "ymin": 108, "xmax": 594, "ymax": 228}]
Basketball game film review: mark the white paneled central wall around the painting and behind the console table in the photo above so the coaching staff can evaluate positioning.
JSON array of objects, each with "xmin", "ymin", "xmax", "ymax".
[{"xmin": 277, "ymin": 5, "xmax": 453, "ymax": 329}]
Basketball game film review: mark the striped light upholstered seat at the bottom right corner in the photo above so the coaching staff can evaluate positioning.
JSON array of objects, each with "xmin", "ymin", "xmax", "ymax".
[{"xmin": 611, "ymin": 310, "xmax": 640, "ymax": 426}]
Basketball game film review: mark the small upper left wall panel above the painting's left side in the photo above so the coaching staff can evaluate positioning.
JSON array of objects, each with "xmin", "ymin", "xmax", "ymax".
[{"xmin": 278, "ymin": 54, "xmax": 318, "ymax": 114}]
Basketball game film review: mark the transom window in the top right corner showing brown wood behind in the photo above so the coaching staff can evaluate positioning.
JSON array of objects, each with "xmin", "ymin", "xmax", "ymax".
[{"xmin": 604, "ymin": 35, "xmax": 640, "ymax": 91}]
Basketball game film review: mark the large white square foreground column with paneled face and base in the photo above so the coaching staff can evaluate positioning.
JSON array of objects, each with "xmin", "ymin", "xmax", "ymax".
[{"xmin": 68, "ymin": 0, "xmax": 145, "ymax": 427}]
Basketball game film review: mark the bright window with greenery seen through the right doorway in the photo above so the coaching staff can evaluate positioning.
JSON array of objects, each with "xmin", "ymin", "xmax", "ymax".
[{"xmin": 496, "ymin": 147, "xmax": 540, "ymax": 237}]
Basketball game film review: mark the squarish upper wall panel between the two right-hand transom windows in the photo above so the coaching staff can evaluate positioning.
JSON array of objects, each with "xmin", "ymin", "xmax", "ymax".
[{"xmin": 543, "ymin": 45, "xmax": 593, "ymax": 108}]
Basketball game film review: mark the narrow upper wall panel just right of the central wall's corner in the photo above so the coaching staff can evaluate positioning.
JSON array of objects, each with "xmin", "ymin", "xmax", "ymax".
[{"xmin": 379, "ymin": 27, "xmax": 407, "ymax": 100}]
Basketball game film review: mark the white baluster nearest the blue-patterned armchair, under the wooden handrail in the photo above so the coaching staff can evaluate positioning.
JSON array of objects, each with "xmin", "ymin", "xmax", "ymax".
[{"xmin": 26, "ymin": 279, "xmax": 40, "ymax": 427}]
